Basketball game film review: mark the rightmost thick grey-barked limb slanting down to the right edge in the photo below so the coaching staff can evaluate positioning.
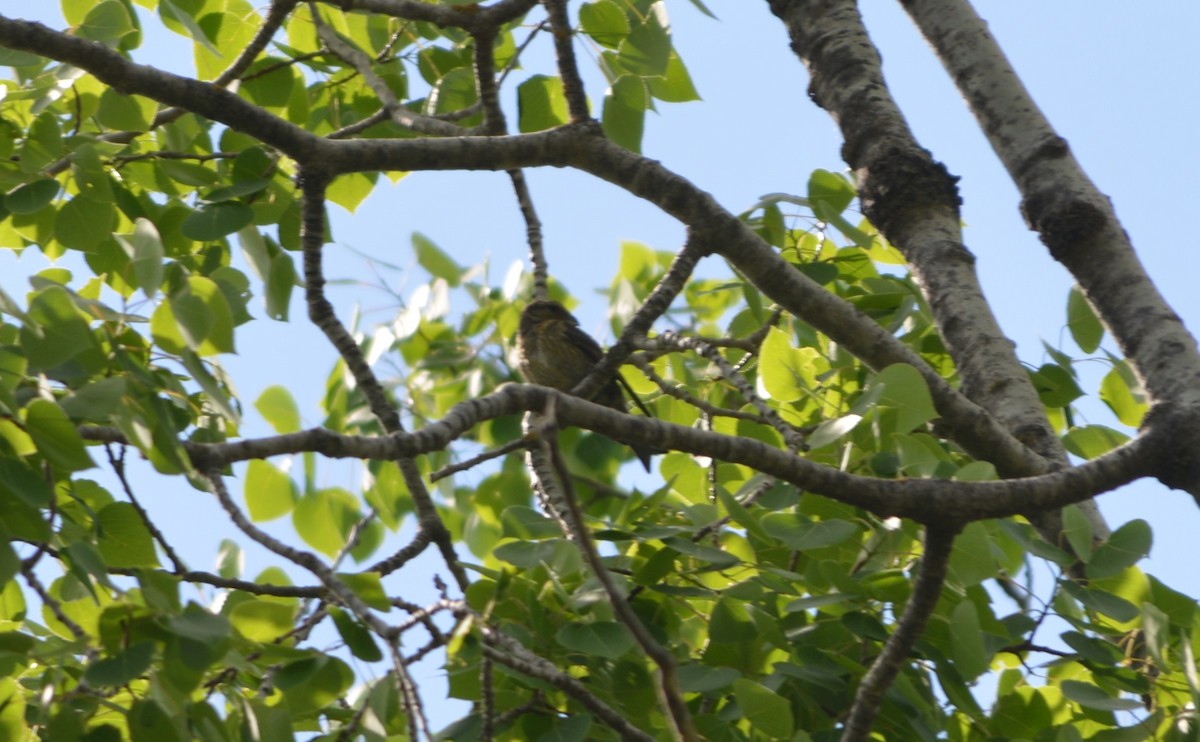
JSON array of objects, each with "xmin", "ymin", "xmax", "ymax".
[{"xmin": 902, "ymin": 0, "xmax": 1200, "ymax": 493}]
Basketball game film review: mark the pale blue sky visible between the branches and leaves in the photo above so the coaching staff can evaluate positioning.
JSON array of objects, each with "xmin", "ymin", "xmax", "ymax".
[{"xmin": 0, "ymin": 0, "xmax": 1200, "ymax": 725}]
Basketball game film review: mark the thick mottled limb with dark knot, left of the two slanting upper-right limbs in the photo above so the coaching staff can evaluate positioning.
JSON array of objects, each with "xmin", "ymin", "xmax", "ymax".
[{"xmin": 770, "ymin": 0, "xmax": 1080, "ymax": 480}]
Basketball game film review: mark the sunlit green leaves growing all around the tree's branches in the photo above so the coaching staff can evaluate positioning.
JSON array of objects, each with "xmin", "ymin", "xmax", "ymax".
[{"xmin": 0, "ymin": 0, "xmax": 1200, "ymax": 740}]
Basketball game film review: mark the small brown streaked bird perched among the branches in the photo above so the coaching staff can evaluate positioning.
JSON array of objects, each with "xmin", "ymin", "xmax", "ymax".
[{"xmin": 517, "ymin": 300, "xmax": 662, "ymax": 472}]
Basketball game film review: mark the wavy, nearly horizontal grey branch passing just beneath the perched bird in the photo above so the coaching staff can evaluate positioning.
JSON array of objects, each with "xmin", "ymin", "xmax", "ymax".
[{"xmin": 80, "ymin": 384, "xmax": 1152, "ymax": 523}]
